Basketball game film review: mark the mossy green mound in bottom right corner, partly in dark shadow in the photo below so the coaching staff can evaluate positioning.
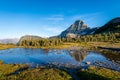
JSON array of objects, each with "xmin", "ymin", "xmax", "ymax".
[{"xmin": 78, "ymin": 66, "xmax": 120, "ymax": 80}]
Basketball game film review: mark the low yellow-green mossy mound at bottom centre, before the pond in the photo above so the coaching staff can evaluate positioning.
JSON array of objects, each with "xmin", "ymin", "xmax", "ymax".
[{"xmin": 8, "ymin": 69, "xmax": 72, "ymax": 80}]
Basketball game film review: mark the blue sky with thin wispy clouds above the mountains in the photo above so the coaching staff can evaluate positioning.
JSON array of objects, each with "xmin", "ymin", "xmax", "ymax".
[{"xmin": 0, "ymin": 0, "xmax": 120, "ymax": 39}]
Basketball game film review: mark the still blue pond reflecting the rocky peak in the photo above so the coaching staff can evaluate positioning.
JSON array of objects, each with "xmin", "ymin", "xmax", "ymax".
[{"xmin": 0, "ymin": 48, "xmax": 120, "ymax": 71}]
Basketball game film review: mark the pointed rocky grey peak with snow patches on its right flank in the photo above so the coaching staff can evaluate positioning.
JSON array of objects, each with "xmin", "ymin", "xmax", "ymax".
[{"xmin": 58, "ymin": 20, "xmax": 97, "ymax": 38}]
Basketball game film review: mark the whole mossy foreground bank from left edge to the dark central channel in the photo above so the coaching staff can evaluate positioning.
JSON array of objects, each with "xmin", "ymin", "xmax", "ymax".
[{"xmin": 0, "ymin": 61, "xmax": 72, "ymax": 80}]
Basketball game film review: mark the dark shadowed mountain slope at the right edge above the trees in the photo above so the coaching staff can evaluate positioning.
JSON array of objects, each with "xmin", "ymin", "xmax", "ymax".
[{"xmin": 95, "ymin": 17, "xmax": 120, "ymax": 34}]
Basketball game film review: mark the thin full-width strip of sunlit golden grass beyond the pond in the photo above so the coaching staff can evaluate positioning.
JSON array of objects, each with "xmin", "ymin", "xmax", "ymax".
[{"xmin": 0, "ymin": 42, "xmax": 120, "ymax": 50}]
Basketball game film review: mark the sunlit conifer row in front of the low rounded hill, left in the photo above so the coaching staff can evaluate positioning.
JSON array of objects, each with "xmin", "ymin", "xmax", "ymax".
[{"xmin": 18, "ymin": 38, "xmax": 62, "ymax": 47}]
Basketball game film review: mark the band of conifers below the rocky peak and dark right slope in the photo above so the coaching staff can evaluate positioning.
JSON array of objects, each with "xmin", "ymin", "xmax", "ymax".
[{"xmin": 61, "ymin": 32, "xmax": 120, "ymax": 42}]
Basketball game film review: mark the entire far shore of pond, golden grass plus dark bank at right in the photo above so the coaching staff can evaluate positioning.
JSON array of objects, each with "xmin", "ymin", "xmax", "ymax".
[{"xmin": 0, "ymin": 42, "xmax": 120, "ymax": 53}]
